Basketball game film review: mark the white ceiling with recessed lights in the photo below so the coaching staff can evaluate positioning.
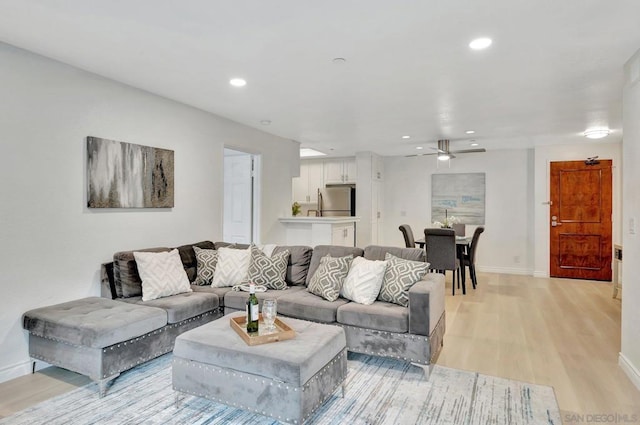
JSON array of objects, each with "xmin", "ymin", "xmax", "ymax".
[{"xmin": 0, "ymin": 0, "xmax": 640, "ymax": 156}]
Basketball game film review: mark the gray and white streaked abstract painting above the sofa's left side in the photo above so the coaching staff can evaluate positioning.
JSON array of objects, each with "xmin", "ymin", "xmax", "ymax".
[{"xmin": 87, "ymin": 137, "xmax": 173, "ymax": 208}]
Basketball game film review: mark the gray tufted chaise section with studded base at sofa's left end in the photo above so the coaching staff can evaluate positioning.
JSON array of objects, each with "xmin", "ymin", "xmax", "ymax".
[{"xmin": 22, "ymin": 297, "xmax": 171, "ymax": 396}]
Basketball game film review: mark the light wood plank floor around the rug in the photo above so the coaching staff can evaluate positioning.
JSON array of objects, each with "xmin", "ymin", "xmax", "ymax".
[{"xmin": 0, "ymin": 273, "xmax": 640, "ymax": 424}]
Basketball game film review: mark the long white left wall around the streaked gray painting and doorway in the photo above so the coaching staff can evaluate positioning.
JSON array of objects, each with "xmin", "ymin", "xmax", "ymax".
[{"xmin": 0, "ymin": 44, "xmax": 298, "ymax": 382}]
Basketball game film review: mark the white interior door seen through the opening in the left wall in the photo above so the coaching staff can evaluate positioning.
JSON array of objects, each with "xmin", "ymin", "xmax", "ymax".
[{"xmin": 222, "ymin": 149, "xmax": 254, "ymax": 243}]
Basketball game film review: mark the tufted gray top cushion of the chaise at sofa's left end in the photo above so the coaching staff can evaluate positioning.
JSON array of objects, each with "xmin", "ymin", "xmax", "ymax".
[{"xmin": 22, "ymin": 297, "xmax": 167, "ymax": 348}]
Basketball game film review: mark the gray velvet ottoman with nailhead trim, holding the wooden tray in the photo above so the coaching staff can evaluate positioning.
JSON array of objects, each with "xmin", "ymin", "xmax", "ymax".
[{"xmin": 172, "ymin": 313, "xmax": 347, "ymax": 424}]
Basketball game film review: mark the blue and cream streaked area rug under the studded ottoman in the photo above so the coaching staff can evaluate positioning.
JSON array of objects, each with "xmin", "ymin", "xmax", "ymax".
[{"xmin": 0, "ymin": 353, "xmax": 562, "ymax": 425}]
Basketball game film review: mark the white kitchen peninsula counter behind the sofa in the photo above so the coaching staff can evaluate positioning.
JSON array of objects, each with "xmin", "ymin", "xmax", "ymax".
[{"xmin": 278, "ymin": 216, "xmax": 360, "ymax": 247}]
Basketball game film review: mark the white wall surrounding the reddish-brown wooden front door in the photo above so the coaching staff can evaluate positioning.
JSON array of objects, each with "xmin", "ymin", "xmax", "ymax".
[{"xmin": 534, "ymin": 141, "xmax": 626, "ymax": 277}]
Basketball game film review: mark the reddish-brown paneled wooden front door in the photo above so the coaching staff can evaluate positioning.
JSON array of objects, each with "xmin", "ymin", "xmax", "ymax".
[{"xmin": 550, "ymin": 160, "xmax": 612, "ymax": 281}]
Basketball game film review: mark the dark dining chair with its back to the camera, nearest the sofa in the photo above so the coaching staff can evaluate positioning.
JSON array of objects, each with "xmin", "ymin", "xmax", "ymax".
[{"xmin": 424, "ymin": 228, "xmax": 467, "ymax": 295}]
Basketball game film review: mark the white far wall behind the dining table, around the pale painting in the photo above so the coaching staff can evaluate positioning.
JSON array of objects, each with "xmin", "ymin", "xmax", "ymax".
[{"xmin": 383, "ymin": 149, "xmax": 533, "ymax": 274}]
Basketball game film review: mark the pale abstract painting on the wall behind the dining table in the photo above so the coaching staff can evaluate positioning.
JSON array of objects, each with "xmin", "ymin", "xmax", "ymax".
[{"xmin": 431, "ymin": 173, "xmax": 486, "ymax": 224}]
